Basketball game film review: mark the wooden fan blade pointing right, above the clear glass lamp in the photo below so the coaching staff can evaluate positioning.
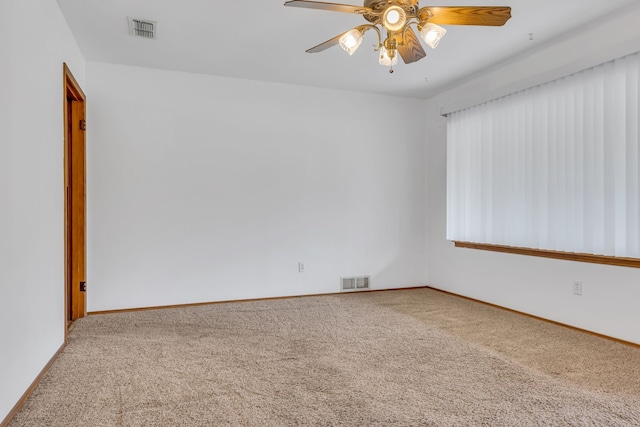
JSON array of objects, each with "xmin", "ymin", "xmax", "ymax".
[{"xmin": 417, "ymin": 6, "xmax": 511, "ymax": 26}]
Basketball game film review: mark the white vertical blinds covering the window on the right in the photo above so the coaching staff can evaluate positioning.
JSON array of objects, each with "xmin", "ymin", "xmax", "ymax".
[{"xmin": 447, "ymin": 52, "xmax": 640, "ymax": 258}]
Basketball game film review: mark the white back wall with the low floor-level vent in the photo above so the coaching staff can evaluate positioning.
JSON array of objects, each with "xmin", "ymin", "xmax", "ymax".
[{"xmin": 87, "ymin": 62, "xmax": 426, "ymax": 311}]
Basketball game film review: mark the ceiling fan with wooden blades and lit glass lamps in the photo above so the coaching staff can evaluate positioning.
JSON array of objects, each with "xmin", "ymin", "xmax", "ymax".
[{"xmin": 284, "ymin": 0, "xmax": 511, "ymax": 73}]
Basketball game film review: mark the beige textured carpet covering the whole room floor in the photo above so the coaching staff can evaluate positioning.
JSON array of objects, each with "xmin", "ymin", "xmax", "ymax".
[{"xmin": 10, "ymin": 289, "xmax": 640, "ymax": 427}]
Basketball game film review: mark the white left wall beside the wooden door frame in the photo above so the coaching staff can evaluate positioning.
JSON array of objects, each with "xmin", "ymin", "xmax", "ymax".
[{"xmin": 0, "ymin": 0, "xmax": 85, "ymax": 421}]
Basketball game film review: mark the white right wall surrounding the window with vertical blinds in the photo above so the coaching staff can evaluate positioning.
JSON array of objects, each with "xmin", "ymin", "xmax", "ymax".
[{"xmin": 425, "ymin": 5, "xmax": 640, "ymax": 343}]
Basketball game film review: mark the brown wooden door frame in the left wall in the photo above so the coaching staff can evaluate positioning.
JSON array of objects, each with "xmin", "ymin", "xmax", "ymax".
[{"xmin": 62, "ymin": 63, "xmax": 87, "ymax": 332}]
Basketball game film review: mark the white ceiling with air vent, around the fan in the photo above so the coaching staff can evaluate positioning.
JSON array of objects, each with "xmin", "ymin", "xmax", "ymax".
[{"xmin": 58, "ymin": 0, "xmax": 638, "ymax": 98}]
